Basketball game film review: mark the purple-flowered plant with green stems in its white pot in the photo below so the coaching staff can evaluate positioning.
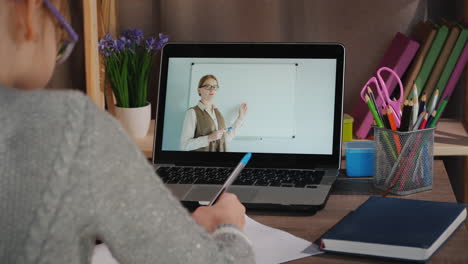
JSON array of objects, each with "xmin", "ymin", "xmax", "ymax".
[{"xmin": 99, "ymin": 29, "xmax": 169, "ymax": 138}]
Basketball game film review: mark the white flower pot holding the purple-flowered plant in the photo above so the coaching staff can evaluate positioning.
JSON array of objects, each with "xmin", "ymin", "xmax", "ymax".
[{"xmin": 115, "ymin": 103, "xmax": 151, "ymax": 138}]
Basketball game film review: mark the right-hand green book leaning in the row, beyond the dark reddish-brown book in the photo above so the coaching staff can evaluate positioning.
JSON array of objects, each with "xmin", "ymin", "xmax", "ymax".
[{"xmin": 428, "ymin": 25, "xmax": 468, "ymax": 102}]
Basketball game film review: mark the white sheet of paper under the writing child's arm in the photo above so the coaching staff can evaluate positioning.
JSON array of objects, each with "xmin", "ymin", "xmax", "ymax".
[{"xmin": 91, "ymin": 216, "xmax": 322, "ymax": 264}]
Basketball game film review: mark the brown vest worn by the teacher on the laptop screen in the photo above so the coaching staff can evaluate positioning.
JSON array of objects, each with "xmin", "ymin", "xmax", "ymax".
[{"xmin": 192, "ymin": 106, "xmax": 226, "ymax": 152}]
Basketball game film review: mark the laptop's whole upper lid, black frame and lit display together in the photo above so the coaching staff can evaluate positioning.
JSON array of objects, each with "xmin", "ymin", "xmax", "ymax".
[{"xmin": 153, "ymin": 44, "xmax": 344, "ymax": 167}]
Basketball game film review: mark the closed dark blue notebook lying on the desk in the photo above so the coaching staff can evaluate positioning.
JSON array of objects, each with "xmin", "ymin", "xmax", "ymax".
[{"xmin": 321, "ymin": 196, "xmax": 466, "ymax": 262}]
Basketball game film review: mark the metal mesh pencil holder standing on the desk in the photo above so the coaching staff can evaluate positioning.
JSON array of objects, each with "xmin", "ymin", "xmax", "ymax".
[{"xmin": 374, "ymin": 127, "xmax": 435, "ymax": 195}]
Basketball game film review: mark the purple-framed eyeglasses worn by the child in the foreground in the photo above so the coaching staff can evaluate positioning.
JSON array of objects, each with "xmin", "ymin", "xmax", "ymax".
[{"xmin": 44, "ymin": 0, "xmax": 78, "ymax": 64}]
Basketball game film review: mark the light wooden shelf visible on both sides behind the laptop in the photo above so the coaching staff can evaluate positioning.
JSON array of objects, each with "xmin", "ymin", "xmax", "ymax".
[{"xmin": 135, "ymin": 119, "xmax": 468, "ymax": 158}]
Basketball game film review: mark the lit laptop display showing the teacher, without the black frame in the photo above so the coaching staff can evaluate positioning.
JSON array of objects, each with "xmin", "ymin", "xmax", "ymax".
[{"xmin": 162, "ymin": 58, "xmax": 337, "ymax": 154}]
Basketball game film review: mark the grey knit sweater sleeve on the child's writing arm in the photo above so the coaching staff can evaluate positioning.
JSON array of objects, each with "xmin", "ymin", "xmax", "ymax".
[{"xmin": 82, "ymin": 99, "xmax": 254, "ymax": 264}]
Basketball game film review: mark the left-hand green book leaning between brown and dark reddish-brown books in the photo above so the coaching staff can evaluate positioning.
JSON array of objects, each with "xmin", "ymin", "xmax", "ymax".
[{"xmin": 408, "ymin": 25, "xmax": 449, "ymax": 100}]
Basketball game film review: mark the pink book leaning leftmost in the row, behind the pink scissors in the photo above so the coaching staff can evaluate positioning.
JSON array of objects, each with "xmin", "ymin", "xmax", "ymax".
[{"xmin": 351, "ymin": 32, "xmax": 419, "ymax": 138}]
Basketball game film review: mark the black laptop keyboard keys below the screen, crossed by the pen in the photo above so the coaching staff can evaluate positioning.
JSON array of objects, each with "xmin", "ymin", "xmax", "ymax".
[{"xmin": 157, "ymin": 167, "xmax": 325, "ymax": 188}]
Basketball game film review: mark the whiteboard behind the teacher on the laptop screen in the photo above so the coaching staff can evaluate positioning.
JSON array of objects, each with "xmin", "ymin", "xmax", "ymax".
[{"xmin": 187, "ymin": 63, "xmax": 297, "ymax": 139}]
